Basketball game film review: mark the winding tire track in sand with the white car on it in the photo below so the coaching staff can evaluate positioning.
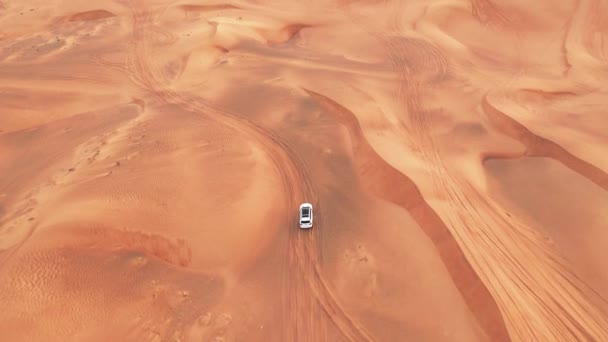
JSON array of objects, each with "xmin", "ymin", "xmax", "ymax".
[{"xmin": 128, "ymin": 5, "xmax": 372, "ymax": 341}]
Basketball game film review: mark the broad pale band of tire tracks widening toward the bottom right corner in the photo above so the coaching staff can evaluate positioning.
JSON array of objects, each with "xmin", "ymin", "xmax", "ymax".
[{"xmin": 383, "ymin": 27, "xmax": 608, "ymax": 341}]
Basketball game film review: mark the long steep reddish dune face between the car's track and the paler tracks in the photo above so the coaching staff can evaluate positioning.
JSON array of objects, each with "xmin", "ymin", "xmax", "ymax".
[{"xmin": 304, "ymin": 89, "xmax": 509, "ymax": 341}]
